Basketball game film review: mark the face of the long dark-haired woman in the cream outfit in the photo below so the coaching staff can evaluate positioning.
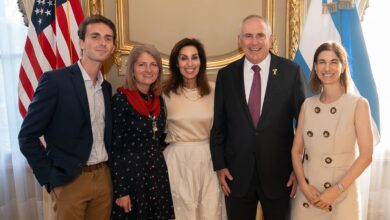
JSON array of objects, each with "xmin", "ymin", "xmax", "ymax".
[{"xmin": 177, "ymin": 46, "xmax": 200, "ymax": 86}]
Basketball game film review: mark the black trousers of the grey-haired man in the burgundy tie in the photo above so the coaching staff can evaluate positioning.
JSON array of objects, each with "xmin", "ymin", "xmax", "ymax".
[{"xmin": 225, "ymin": 169, "xmax": 290, "ymax": 220}]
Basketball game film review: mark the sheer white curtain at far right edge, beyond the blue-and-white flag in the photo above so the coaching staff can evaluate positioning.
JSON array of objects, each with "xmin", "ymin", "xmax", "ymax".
[{"xmin": 362, "ymin": 1, "xmax": 390, "ymax": 220}]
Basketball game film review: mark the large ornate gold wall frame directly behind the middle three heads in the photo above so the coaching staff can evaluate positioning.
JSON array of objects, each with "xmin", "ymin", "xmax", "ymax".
[{"xmin": 114, "ymin": 0, "xmax": 277, "ymax": 75}]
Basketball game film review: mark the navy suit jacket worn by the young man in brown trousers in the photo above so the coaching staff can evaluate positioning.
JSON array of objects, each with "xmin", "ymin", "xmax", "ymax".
[{"xmin": 19, "ymin": 63, "xmax": 112, "ymax": 192}]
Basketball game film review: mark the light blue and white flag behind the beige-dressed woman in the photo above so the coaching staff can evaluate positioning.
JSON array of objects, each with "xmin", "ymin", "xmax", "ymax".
[{"xmin": 294, "ymin": 0, "xmax": 380, "ymax": 145}]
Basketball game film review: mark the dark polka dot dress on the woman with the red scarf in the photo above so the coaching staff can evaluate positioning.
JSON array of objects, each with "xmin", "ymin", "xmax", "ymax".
[{"xmin": 110, "ymin": 93, "xmax": 175, "ymax": 220}]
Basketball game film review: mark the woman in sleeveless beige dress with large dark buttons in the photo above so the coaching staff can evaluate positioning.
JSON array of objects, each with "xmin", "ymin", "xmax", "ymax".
[{"xmin": 291, "ymin": 42, "xmax": 373, "ymax": 220}]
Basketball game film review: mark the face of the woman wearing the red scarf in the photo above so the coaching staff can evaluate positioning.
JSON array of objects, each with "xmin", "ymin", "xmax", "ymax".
[{"xmin": 133, "ymin": 52, "xmax": 159, "ymax": 94}]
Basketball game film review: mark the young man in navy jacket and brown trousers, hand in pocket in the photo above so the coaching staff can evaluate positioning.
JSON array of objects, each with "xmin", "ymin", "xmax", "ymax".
[{"xmin": 19, "ymin": 16, "xmax": 116, "ymax": 220}]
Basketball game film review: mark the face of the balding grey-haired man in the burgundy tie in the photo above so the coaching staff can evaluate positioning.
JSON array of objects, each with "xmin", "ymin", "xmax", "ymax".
[{"xmin": 238, "ymin": 17, "xmax": 272, "ymax": 64}]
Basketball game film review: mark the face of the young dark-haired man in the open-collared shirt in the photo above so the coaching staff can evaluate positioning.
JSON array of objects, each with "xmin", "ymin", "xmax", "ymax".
[{"xmin": 79, "ymin": 23, "xmax": 115, "ymax": 63}]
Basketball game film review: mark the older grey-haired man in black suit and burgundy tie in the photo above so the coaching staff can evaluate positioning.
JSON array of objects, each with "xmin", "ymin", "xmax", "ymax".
[{"xmin": 210, "ymin": 15, "xmax": 306, "ymax": 220}]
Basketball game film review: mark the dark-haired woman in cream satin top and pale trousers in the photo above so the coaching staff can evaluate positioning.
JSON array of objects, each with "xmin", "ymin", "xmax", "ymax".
[{"xmin": 164, "ymin": 38, "xmax": 223, "ymax": 220}]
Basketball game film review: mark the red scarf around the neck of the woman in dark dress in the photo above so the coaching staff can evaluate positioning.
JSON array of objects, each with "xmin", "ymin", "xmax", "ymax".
[{"xmin": 117, "ymin": 87, "xmax": 161, "ymax": 119}]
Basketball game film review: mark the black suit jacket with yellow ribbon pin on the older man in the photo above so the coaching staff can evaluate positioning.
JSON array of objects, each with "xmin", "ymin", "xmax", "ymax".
[{"xmin": 210, "ymin": 54, "xmax": 306, "ymax": 198}]
